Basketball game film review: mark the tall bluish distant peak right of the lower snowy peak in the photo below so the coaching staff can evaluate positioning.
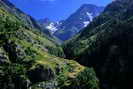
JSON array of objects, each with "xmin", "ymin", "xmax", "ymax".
[{"xmin": 54, "ymin": 4, "xmax": 104, "ymax": 41}]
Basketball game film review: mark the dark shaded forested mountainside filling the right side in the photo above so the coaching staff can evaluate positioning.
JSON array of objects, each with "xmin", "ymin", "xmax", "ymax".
[{"xmin": 64, "ymin": 0, "xmax": 133, "ymax": 89}]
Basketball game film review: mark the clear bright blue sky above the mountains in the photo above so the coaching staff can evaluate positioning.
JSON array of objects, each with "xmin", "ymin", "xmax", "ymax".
[{"xmin": 10, "ymin": 0, "xmax": 111, "ymax": 21}]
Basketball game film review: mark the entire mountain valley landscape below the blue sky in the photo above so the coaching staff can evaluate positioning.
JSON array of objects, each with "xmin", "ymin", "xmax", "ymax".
[{"xmin": 0, "ymin": 0, "xmax": 133, "ymax": 89}]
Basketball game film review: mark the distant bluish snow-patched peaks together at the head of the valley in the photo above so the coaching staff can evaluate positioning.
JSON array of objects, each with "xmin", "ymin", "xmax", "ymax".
[{"xmin": 39, "ymin": 4, "xmax": 104, "ymax": 41}]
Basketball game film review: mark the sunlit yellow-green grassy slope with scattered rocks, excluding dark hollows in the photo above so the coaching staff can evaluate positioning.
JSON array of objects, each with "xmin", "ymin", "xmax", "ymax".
[{"xmin": 0, "ymin": 4, "xmax": 98, "ymax": 89}]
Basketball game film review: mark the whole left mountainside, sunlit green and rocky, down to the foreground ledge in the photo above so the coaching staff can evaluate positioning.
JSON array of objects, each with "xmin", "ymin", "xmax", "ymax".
[{"xmin": 0, "ymin": 0, "xmax": 99, "ymax": 89}]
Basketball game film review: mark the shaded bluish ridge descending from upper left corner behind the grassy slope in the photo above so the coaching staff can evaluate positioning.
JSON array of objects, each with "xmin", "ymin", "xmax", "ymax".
[{"xmin": 0, "ymin": 0, "xmax": 65, "ymax": 54}]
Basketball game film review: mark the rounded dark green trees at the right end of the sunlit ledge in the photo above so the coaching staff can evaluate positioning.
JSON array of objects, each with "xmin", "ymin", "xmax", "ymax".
[{"xmin": 70, "ymin": 69, "xmax": 99, "ymax": 89}]
